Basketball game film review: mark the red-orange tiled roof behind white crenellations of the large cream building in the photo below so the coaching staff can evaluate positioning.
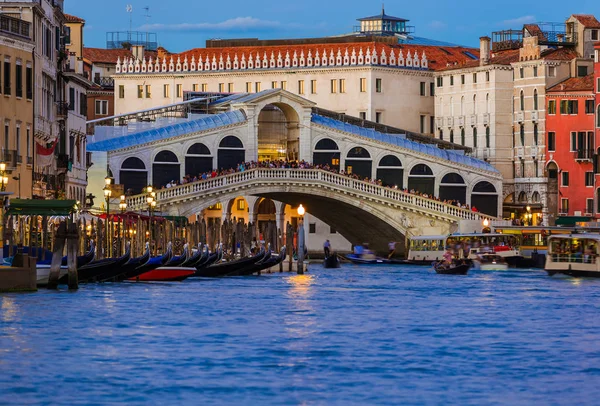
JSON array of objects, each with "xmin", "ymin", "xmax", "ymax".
[{"xmin": 166, "ymin": 42, "xmax": 479, "ymax": 70}]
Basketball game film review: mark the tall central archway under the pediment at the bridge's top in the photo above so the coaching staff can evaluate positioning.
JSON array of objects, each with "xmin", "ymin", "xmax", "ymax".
[{"xmin": 258, "ymin": 103, "xmax": 300, "ymax": 161}]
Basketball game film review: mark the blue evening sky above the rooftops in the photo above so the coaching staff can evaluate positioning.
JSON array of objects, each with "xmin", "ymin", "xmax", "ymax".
[{"xmin": 65, "ymin": 0, "xmax": 600, "ymax": 52}]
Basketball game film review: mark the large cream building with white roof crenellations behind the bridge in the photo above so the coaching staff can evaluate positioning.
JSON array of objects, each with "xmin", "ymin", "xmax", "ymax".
[{"xmin": 114, "ymin": 13, "xmax": 478, "ymax": 134}]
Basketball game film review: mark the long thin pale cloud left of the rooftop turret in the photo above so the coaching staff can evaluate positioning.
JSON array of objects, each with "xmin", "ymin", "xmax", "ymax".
[{"xmin": 139, "ymin": 17, "xmax": 289, "ymax": 32}]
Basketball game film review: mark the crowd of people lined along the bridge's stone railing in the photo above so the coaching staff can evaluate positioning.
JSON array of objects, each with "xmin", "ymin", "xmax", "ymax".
[{"xmin": 161, "ymin": 159, "xmax": 478, "ymax": 212}]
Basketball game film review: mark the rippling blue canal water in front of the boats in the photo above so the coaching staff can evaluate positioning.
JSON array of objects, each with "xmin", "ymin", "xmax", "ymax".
[{"xmin": 0, "ymin": 265, "xmax": 600, "ymax": 405}]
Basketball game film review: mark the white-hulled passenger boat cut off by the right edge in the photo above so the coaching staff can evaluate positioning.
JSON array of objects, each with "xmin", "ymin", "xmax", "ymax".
[{"xmin": 545, "ymin": 233, "xmax": 600, "ymax": 278}]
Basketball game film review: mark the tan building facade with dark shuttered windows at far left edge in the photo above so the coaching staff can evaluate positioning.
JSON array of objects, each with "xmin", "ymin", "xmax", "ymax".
[{"xmin": 0, "ymin": 15, "xmax": 34, "ymax": 199}]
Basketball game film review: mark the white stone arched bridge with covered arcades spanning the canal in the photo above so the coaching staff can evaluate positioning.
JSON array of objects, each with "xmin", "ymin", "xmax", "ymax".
[{"xmin": 88, "ymin": 89, "xmax": 502, "ymax": 249}]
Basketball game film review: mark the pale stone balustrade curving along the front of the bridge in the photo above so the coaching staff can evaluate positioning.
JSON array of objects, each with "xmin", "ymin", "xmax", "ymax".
[{"xmin": 127, "ymin": 168, "xmax": 496, "ymax": 220}]
